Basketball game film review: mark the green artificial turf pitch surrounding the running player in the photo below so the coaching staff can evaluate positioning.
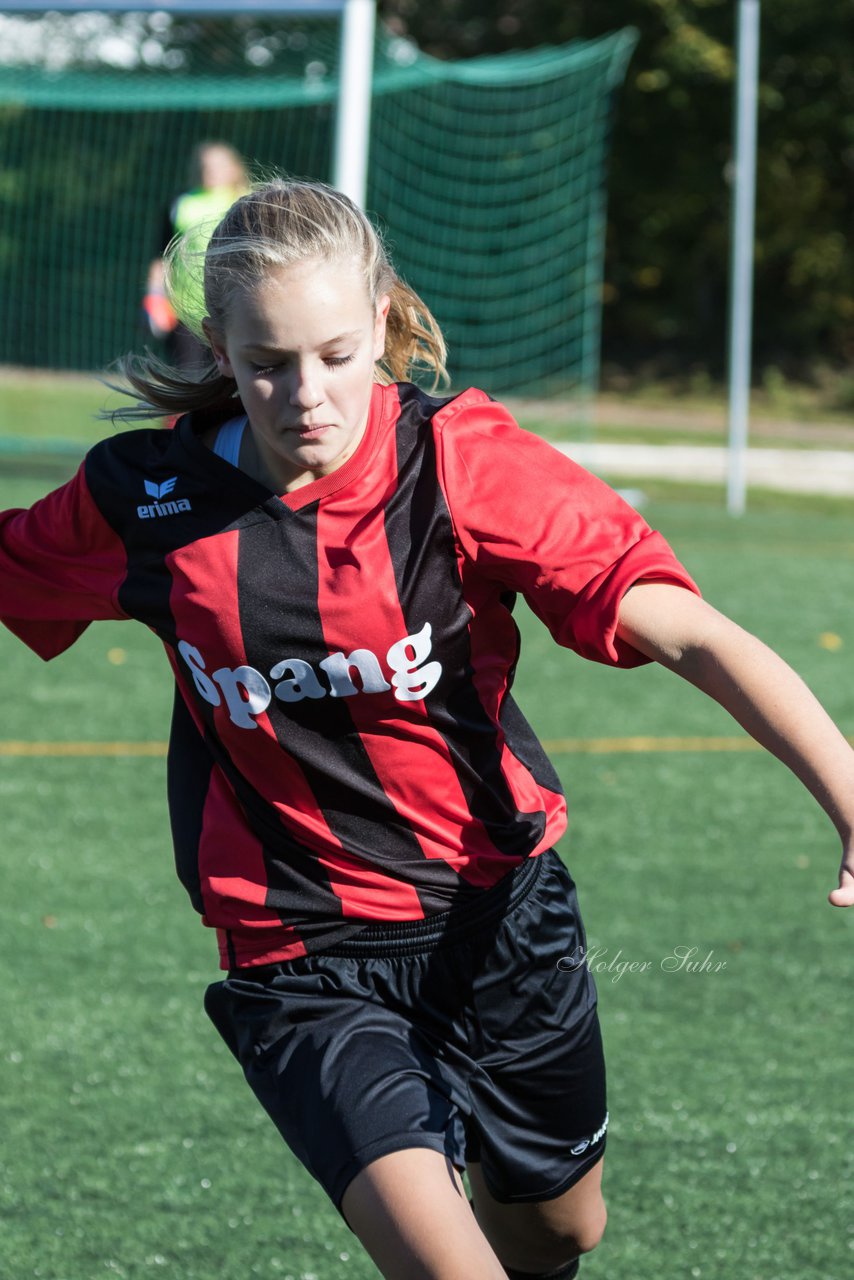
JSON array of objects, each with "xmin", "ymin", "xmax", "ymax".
[{"xmin": 0, "ymin": 458, "xmax": 854, "ymax": 1280}]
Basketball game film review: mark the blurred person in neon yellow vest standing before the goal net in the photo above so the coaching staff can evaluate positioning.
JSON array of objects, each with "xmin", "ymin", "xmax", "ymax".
[{"xmin": 142, "ymin": 142, "xmax": 250, "ymax": 369}]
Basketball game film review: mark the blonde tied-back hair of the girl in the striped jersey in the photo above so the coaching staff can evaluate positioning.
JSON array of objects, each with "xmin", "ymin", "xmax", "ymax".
[{"xmin": 111, "ymin": 179, "xmax": 447, "ymax": 421}]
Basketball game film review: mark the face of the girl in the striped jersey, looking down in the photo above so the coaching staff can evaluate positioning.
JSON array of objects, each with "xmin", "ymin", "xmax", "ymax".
[{"xmin": 205, "ymin": 261, "xmax": 389, "ymax": 493}]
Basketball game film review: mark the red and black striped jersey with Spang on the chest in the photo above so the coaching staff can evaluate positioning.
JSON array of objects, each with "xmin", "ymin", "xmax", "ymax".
[{"xmin": 0, "ymin": 384, "xmax": 697, "ymax": 968}]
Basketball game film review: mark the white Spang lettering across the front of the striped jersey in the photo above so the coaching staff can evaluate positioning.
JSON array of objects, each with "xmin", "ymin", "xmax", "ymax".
[{"xmin": 178, "ymin": 622, "xmax": 442, "ymax": 728}]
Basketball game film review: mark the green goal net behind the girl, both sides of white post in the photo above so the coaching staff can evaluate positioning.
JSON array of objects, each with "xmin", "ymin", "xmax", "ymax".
[{"xmin": 0, "ymin": 9, "xmax": 635, "ymax": 394}]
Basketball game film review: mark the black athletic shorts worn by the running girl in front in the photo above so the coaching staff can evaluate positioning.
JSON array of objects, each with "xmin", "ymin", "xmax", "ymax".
[{"xmin": 205, "ymin": 851, "xmax": 607, "ymax": 1208}]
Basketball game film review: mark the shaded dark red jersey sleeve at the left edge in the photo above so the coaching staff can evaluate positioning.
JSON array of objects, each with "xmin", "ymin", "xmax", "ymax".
[{"xmin": 0, "ymin": 465, "xmax": 127, "ymax": 659}]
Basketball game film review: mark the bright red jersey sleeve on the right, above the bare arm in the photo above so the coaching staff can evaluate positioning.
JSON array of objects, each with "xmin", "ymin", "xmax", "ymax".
[{"xmin": 437, "ymin": 390, "xmax": 699, "ymax": 667}]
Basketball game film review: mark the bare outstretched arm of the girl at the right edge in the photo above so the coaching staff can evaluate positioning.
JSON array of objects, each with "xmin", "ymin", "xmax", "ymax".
[{"xmin": 617, "ymin": 581, "xmax": 854, "ymax": 906}]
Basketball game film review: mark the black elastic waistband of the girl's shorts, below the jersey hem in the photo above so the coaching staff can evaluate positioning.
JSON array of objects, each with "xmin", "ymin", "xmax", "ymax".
[{"xmin": 317, "ymin": 854, "xmax": 544, "ymax": 956}]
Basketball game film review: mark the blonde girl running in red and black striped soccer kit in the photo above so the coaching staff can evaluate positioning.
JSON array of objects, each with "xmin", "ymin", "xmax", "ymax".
[{"xmin": 0, "ymin": 182, "xmax": 854, "ymax": 1280}]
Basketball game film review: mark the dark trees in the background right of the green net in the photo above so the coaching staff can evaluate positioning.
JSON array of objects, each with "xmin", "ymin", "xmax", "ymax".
[{"xmin": 382, "ymin": 0, "xmax": 854, "ymax": 386}]
